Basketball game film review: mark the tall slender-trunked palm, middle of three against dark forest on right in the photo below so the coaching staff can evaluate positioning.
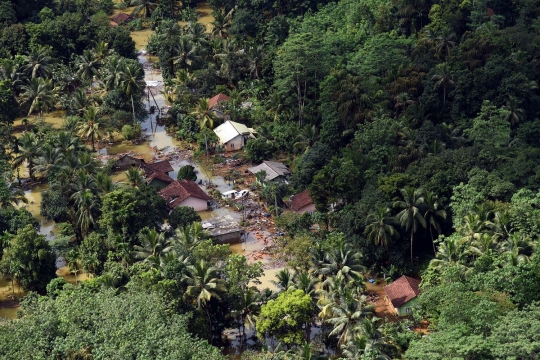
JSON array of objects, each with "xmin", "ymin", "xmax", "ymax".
[{"xmin": 394, "ymin": 186, "xmax": 426, "ymax": 264}]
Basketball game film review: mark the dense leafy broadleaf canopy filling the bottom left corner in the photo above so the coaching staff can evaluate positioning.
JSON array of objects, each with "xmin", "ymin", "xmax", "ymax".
[{"xmin": 0, "ymin": 286, "xmax": 222, "ymax": 360}]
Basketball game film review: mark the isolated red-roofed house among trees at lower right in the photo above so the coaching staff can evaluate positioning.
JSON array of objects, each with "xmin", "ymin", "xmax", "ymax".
[{"xmin": 383, "ymin": 275, "xmax": 420, "ymax": 316}]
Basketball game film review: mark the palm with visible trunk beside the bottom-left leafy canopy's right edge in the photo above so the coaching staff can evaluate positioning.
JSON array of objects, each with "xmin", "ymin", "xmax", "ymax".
[{"xmin": 184, "ymin": 260, "xmax": 227, "ymax": 334}]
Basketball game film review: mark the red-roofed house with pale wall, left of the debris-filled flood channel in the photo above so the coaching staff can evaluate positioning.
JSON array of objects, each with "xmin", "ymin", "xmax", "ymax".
[{"xmin": 158, "ymin": 180, "xmax": 211, "ymax": 211}]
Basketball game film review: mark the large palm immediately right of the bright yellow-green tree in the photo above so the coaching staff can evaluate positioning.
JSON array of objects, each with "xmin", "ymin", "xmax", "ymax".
[{"xmin": 325, "ymin": 289, "xmax": 375, "ymax": 346}]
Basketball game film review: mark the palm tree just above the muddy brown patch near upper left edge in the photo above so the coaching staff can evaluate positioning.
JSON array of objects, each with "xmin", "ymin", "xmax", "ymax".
[{"xmin": 21, "ymin": 78, "xmax": 55, "ymax": 117}]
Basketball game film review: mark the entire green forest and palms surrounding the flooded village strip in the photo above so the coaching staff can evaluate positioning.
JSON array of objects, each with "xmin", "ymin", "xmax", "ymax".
[{"xmin": 0, "ymin": 0, "xmax": 540, "ymax": 360}]
